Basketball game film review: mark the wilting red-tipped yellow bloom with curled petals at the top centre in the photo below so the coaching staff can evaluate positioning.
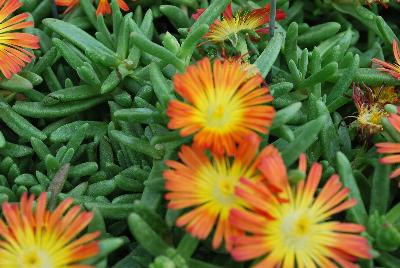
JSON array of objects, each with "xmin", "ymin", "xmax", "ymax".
[{"xmin": 193, "ymin": 4, "xmax": 286, "ymax": 43}]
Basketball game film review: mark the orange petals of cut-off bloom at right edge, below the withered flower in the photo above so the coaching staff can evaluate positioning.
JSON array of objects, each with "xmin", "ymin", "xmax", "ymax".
[{"xmin": 376, "ymin": 107, "xmax": 400, "ymax": 178}]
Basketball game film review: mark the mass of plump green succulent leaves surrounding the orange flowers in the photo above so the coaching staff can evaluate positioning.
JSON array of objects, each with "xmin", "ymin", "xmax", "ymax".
[{"xmin": 0, "ymin": 0, "xmax": 400, "ymax": 268}]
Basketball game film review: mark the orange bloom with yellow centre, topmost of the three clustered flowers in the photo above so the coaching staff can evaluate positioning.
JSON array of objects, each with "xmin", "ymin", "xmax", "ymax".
[{"xmin": 167, "ymin": 58, "xmax": 275, "ymax": 155}]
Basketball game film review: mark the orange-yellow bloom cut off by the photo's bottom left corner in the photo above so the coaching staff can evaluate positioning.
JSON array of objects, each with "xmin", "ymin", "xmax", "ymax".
[{"xmin": 0, "ymin": 193, "xmax": 99, "ymax": 268}]
